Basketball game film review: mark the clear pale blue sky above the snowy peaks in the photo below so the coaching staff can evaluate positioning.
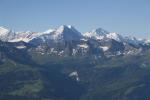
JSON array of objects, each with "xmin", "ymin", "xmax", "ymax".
[{"xmin": 0, "ymin": 0, "xmax": 150, "ymax": 38}]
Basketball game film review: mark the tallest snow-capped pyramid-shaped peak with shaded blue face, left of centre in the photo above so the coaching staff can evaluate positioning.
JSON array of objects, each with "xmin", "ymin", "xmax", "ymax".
[{"xmin": 23, "ymin": 25, "xmax": 82, "ymax": 42}]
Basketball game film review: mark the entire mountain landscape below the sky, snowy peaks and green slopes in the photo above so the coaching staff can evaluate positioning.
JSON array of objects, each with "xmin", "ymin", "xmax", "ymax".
[{"xmin": 0, "ymin": 25, "xmax": 150, "ymax": 100}]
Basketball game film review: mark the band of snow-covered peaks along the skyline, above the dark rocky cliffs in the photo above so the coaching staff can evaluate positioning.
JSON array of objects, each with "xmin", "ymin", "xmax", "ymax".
[{"xmin": 0, "ymin": 25, "xmax": 150, "ymax": 44}]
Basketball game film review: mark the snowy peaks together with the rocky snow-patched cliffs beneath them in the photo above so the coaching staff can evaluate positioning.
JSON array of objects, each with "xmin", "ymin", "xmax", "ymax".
[{"xmin": 0, "ymin": 25, "xmax": 150, "ymax": 57}]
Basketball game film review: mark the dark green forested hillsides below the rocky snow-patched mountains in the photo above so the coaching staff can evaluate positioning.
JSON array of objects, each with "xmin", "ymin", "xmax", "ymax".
[{"xmin": 0, "ymin": 40, "xmax": 150, "ymax": 100}]
